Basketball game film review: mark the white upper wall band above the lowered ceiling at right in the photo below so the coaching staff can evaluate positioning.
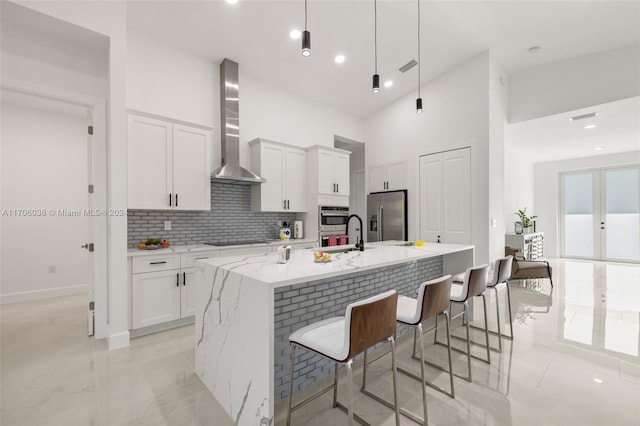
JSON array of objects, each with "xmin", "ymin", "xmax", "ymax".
[{"xmin": 509, "ymin": 44, "xmax": 640, "ymax": 123}]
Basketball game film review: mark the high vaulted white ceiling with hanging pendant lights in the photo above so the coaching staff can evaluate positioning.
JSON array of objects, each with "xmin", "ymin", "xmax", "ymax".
[{"xmin": 127, "ymin": 0, "xmax": 640, "ymax": 117}]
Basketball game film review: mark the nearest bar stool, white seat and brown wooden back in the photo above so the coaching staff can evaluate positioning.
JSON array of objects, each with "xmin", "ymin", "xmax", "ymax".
[{"xmin": 287, "ymin": 290, "xmax": 400, "ymax": 426}]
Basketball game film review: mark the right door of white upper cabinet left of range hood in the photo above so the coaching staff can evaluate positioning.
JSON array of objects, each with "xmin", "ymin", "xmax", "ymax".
[{"xmin": 173, "ymin": 124, "xmax": 211, "ymax": 210}]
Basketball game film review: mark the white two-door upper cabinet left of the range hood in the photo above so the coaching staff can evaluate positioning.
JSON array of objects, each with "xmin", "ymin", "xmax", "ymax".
[{"xmin": 128, "ymin": 114, "xmax": 211, "ymax": 210}]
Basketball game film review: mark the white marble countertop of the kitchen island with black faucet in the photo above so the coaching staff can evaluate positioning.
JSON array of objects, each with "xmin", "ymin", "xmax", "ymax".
[{"xmin": 197, "ymin": 241, "xmax": 473, "ymax": 288}]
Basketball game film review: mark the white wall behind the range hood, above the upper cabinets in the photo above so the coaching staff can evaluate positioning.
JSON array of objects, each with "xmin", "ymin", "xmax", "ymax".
[{"xmin": 127, "ymin": 33, "xmax": 363, "ymax": 173}]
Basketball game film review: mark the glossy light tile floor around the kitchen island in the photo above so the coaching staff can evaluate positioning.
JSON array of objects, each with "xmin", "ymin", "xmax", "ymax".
[{"xmin": 0, "ymin": 260, "xmax": 640, "ymax": 426}]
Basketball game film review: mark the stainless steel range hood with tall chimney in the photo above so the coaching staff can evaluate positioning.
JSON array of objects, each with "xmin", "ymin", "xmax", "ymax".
[{"xmin": 211, "ymin": 58, "xmax": 267, "ymax": 184}]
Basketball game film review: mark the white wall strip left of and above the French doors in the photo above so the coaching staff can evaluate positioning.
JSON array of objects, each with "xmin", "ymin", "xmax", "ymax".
[{"xmin": 535, "ymin": 151, "xmax": 640, "ymax": 257}]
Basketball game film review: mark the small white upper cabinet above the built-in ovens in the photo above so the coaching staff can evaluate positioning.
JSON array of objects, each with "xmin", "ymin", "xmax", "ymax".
[{"xmin": 309, "ymin": 146, "xmax": 350, "ymax": 196}]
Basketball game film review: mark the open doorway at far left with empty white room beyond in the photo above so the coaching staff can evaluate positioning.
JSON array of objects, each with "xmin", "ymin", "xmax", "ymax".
[{"xmin": 1, "ymin": 89, "xmax": 107, "ymax": 338}]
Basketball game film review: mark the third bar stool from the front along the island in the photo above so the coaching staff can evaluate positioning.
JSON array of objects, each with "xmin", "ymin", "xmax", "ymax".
[{"xmin": 434, "ymin": 264, "xmax": 491, "ymax": 382}]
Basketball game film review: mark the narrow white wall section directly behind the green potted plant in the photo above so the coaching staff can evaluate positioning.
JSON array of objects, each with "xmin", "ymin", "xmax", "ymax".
[{"xmin": 504, "ymin": 143, "xmax": 541, "ymax": 234}]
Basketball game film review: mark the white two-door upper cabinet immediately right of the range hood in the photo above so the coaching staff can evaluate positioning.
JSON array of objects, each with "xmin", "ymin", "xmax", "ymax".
[{"xmin": 249, "ymin": 139, "xmax": 307, "ymax": 212}]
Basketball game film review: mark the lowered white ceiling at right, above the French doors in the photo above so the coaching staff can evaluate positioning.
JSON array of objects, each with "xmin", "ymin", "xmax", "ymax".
[{"xmin": 505, "ymin": 97, "xmax": 640, "ymax": 163}]
